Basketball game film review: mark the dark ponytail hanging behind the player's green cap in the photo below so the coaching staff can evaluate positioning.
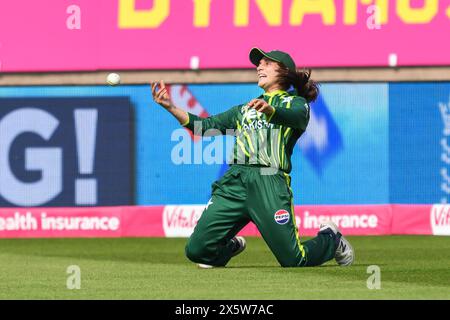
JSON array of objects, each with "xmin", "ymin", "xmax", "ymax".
[{"xmin": 279, "ymin": 64, "xmax": 319, "ymax": 103}]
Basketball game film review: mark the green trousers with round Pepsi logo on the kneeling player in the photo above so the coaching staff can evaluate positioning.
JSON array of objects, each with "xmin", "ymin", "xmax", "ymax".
[{"xmin": 185, "ymin": 164, "xmax": 337, "ymax": 267}]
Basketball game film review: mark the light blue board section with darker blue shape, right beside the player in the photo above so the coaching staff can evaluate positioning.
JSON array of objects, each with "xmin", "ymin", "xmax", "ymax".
[{"xmin": 292, "ymin": 83, "xmax": 389, "ymax": 204}]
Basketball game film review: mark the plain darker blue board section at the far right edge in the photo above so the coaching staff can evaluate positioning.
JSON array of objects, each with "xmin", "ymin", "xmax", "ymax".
[{"xmin": 389, "ymin": 83, "xmax": 450, "ymax": 203}]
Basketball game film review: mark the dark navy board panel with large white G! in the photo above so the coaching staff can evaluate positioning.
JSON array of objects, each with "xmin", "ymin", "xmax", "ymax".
[{"xmin": 0, "ymin": 96, "xmax": 134, "ymax": 207}]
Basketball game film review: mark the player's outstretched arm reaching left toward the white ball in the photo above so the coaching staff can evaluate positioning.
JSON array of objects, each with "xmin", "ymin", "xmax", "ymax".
[{"xmin": 152, "ymin": 81, "xmax": 238, "ymax": 136}]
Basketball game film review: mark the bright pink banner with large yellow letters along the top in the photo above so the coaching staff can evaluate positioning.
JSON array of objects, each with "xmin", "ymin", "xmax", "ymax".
[{"xmin": 0, "ymin": 0, "xmax": 450, "ymax": 72}]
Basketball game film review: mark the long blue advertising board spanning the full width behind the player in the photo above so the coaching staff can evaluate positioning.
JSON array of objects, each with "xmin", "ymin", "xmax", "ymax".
[{"xmin": 0, "ymin": 83, "xmax": 450, "ymax": 206}]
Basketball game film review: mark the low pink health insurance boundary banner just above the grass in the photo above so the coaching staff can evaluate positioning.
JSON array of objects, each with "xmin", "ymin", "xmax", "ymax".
[{"xmin": 0, "ymin": 205, "xmax": 450, "ymax": 238}]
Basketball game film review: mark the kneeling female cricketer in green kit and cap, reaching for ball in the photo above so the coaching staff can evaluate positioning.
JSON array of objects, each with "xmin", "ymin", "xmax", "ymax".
[{"xmin": 151, "ymin": 48, "xmax": 354, "ymax": 268}]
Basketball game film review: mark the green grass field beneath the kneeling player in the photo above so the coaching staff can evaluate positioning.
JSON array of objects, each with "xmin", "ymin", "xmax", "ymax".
[{"xmin": 0, "ymin": 236, "xmax": 450, "ymax": 300}]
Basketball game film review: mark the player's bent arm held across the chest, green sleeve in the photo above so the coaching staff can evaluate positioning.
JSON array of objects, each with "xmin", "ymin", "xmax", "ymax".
[{"xmin": 249, "ymin": 97, "xmax": 310, "ymax": 131}]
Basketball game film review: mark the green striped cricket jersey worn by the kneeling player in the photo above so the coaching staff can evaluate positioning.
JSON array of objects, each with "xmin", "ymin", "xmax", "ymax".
[{"xmin": 183, "ymin": 90, "xmax": 310, "ymax": 173}]
